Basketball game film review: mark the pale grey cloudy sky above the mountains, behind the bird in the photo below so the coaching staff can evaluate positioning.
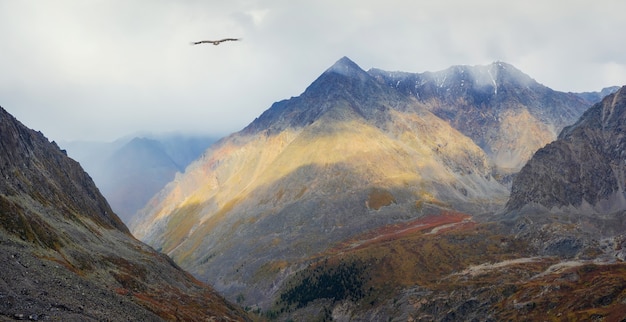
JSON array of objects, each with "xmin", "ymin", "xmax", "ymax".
[{"xmin": 0, "ymin": 0, "xmax": 626, "ymax": 141}]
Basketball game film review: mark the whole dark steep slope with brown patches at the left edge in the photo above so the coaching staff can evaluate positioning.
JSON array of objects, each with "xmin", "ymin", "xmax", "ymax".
[{"xmin": 0, "ymin": 108, "xmax": 247, "ymax": 321}]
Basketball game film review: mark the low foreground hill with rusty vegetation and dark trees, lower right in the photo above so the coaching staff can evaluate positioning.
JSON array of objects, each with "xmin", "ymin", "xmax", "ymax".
[{"xmin": 265, "ymin": 213, "xmax": 626, "ymax": 321}]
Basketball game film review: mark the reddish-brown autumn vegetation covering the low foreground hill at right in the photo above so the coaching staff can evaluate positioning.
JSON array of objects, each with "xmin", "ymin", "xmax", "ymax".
[{"xmin": 274, "ymin": 212, "xmax": 626, "ymax": 321}]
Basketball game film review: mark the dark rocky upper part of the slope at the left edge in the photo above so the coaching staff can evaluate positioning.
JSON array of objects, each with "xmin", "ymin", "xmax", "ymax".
[{"xmin": 0, "ymin": 108, "xmax": 128, "ymax": 234}]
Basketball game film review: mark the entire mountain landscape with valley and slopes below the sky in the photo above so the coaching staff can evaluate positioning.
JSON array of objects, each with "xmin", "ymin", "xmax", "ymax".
[{"xmin": 0, "ymin": 57, "xmax": 626, "ymax": 321}]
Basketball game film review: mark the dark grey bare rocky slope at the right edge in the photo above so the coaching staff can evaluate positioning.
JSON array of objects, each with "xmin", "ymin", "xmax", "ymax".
[{"xmin": 507, "ymin": 87, "xmax": 626, "ymax": 213}]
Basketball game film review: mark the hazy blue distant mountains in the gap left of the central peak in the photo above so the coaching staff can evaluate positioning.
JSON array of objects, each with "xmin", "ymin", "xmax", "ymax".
[{"xmin": 60, "ymin": 134, "xmax": 216, "ymax": 223}]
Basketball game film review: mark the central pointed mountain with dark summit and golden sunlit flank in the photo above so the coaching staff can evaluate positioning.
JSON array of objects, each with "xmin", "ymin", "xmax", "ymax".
[{"xmin": 132, "ymin": 57, "xmax": 507, "ymax": 307}]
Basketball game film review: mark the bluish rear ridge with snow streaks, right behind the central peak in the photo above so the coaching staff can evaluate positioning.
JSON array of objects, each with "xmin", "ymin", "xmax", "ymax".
[{"xmin": 369, "ymin": 62, "xmax": 593, "ymax": 175}]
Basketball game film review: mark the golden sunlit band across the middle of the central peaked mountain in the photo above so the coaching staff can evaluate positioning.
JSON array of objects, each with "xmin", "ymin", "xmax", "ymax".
[{"xmin": 134, "ymin": 104, "xmax": 504, "ymax": 251}]
